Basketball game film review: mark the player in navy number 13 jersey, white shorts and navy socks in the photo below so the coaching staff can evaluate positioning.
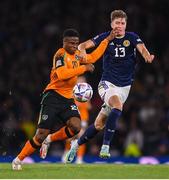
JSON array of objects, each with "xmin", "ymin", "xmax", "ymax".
[{"xmin": 66, "ymin": 10, "xmax": 154, "ymax": 162}]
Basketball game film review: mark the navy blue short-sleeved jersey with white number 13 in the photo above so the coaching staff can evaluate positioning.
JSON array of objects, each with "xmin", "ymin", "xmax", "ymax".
[{"xmin": 92, "ymin": 31, "xmax": 143, "ymax": 87}]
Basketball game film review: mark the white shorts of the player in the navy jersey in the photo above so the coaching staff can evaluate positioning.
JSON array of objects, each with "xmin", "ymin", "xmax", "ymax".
[{"xmin": 98, "ymin": 81, "xmax": 131, "ymax": 116}]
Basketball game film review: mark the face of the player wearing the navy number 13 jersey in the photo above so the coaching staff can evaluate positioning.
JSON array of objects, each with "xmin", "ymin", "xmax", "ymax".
[{"xmin": 111, "ymin": 18, "xmax": 127, "ymax": 36}]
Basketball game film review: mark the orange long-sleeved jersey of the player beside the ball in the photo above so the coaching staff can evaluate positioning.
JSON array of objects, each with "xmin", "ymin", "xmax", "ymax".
[{"xmin": 44, "ymin": 39, "xmax": 108, "ymax": 99}]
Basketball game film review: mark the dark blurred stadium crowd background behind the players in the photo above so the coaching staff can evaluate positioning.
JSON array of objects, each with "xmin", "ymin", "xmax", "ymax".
[{"xmin": 0, "ymin": 0, "xmax": 169, "ymax": 164}]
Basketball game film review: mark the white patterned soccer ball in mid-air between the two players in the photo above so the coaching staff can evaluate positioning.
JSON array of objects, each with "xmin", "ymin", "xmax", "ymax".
[{"xmin": 73, "ymin": 83, "xmax": 93, "ymax": 102}]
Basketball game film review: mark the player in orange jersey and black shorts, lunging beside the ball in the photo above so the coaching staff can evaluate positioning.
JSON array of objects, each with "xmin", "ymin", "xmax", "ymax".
[{"xmin": 12, "ymin": 29, "xmax": 114, "ymax": 170}]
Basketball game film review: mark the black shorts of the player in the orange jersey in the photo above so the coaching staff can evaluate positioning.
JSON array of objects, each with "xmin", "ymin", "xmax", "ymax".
[{"xmin": 38, "ymin": 90, "xmax": 80, "ymax": 130}]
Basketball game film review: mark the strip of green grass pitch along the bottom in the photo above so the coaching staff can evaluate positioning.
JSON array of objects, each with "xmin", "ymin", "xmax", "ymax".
[{"xmin": 0, "ymin": 163, "xmax": 169, "ymax": 179}]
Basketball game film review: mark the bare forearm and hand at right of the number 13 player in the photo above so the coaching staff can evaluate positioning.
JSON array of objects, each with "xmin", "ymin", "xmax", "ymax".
[{"xmin": 136, "ymin": 44, "xmax": 154, "ymax": 63}]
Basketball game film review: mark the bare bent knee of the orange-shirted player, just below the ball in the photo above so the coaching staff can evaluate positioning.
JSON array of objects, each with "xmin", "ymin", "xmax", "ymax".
[{"xmin": 68, "ymin": 117, "xmax": 81, "ymax": 135}]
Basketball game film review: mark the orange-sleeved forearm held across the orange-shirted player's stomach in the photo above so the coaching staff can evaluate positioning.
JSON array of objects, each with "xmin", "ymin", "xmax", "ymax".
[{"xmin": 56, "ymin": 65, "xmax": 86, "ymax": 80}]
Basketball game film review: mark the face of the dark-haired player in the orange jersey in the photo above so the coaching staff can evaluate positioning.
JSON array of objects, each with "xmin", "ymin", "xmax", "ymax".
[{"xmin": 63, "ymin": 37, "xmax": 79, "ymax": 54}]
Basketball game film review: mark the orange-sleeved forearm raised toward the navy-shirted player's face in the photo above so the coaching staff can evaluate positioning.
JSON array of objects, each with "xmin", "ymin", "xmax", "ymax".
[{"xmin": 86, "ymin": 39, "xmax": 109, "ymax": 63}]
